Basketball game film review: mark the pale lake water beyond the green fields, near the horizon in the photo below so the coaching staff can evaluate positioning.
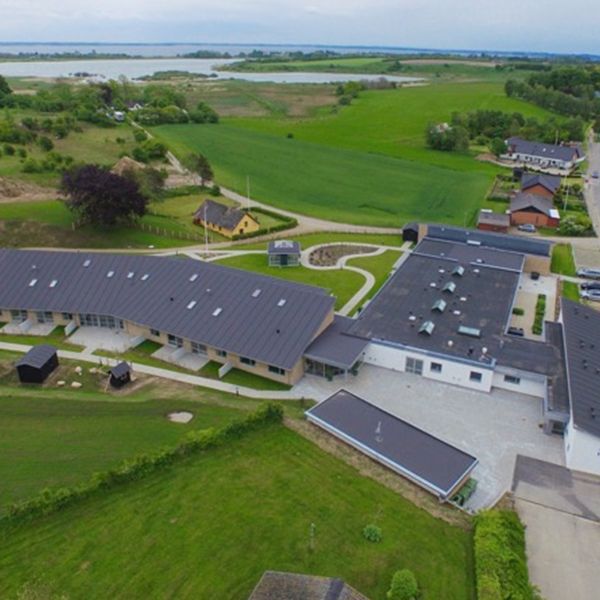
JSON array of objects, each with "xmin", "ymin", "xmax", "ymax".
[{"xmin": 0, "ymin": 58, "xmax": 419, "ymax": 83}]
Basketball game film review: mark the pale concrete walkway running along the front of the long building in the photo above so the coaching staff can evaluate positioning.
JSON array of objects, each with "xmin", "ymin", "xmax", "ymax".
[{"xmin": 0, "ymin": 342, "xmax": 301, "ymax": 400}]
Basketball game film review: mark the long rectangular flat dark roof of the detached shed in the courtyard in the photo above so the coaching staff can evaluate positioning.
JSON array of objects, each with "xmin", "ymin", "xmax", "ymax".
[{"xmin": 306, "ymin": 390, "xmax": 477, "ymax": 498}]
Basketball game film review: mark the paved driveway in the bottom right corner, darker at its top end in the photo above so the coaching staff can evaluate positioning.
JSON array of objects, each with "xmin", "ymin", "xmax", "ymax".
[{"xmin": 513, "ymin": 456, "xmax": 600, "ymax": 600}]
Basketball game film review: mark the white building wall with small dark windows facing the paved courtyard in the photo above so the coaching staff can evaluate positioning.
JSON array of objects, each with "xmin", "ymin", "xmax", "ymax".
[{"xmin": 364, "ymin": 342, "xmax": 493, "ymax": 392}]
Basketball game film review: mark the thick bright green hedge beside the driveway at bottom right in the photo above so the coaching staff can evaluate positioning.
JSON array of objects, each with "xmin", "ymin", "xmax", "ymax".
[{"xmin": 475, "ymin": 509, "xmax": 541, "ymax": 600}]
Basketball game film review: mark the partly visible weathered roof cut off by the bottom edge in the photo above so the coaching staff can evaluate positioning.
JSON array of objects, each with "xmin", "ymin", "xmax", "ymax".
[{"xmin": 248, "ymin": 571, "xmax": 367, "ymax": 600}]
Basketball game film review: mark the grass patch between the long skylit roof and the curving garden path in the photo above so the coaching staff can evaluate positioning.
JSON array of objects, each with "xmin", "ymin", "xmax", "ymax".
[{"xmin": 217, "ymin": 254, "xmax": 364, "ymax": 310}]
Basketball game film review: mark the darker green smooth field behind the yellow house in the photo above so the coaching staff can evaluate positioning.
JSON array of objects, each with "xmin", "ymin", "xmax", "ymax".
[{"xmin": 153, "ymin": 124, "xmax": 491, "ymax": 227}]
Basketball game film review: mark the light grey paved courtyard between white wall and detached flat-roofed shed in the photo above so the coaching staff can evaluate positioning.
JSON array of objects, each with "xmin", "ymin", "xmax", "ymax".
[{"xmin": 294, "ymin": 365, "xmax": 564, "ymax": 510}]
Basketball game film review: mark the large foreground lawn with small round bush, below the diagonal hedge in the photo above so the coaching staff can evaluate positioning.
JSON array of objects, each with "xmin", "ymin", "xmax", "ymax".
[{"xmin": 0, "ymin": 425, "xmax": 473, "ymax": 600}]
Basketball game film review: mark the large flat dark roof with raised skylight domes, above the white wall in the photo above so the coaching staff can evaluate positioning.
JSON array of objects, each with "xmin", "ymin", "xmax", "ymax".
[{"xmin": 349, "ymin": 238, "xmax": 523, "ymax": 365}]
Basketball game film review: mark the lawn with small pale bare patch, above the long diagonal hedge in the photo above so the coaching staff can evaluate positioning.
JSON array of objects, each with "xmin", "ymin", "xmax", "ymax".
[{"xmin": 0, "ymin": 387, "xmax": 243, "ymax": 508}]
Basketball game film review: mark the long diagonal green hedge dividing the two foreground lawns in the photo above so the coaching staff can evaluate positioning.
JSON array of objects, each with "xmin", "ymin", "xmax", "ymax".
[{"xmin": 0, "ymin": 403, "xmax": 283, "ymax": 526}]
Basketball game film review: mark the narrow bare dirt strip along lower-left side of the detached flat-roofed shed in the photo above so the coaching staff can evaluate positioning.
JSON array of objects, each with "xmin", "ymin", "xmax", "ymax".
[{"xmin": 285, "ymin": 419, "xmax": 471, "ymax": 529}]
